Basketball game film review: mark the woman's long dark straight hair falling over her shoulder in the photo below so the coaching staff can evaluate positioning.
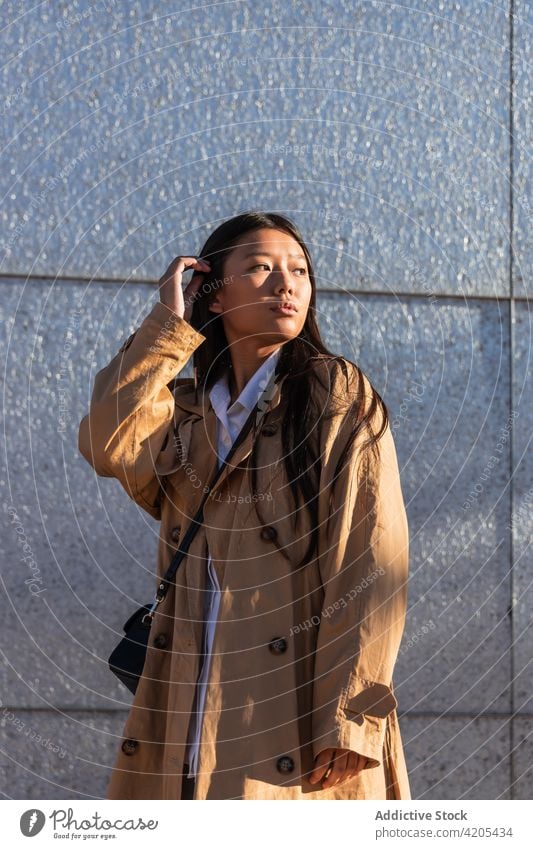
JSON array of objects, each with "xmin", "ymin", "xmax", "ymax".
[{"xmin": 190, "ymin": 210, "xmax": 389, "ymax": 568}]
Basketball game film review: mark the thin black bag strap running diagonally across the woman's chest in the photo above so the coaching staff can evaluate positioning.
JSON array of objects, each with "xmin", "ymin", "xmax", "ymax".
[{"xmin": 142, "ymin": 366, "xmax": 279, "ymax": 625}]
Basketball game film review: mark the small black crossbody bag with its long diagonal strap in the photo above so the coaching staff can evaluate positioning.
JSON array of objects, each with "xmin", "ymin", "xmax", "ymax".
[{"xmin": 108, "ymin": 369, "xmax": 278, "ymax": 693}]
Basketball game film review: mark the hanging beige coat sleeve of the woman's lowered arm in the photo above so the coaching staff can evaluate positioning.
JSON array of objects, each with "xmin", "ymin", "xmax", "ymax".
[{"xmin": 313, "ymin": 364, "xmax": 409, "ymax": 768}]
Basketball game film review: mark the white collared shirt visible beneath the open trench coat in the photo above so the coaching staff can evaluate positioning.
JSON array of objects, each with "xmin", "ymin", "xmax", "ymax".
[{"xmin": 185, "ymin": 348, "xmax": 281, "ymax": 778}]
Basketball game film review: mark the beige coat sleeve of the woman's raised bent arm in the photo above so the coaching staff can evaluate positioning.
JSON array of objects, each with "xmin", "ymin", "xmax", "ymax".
[{"xmin": 78, "ymin": 301, "xmax": 206, "ymax": 519}]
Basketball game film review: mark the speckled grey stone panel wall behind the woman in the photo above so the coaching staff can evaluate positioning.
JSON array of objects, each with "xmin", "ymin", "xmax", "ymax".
[{"xmin": 0, "ymin": 0, "xmax": 533, "ymax": 799}]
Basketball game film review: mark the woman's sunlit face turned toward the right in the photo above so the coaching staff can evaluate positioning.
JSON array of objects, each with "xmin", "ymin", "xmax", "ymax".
[{"xmin": 205, "ymin": 228, "xmax": 312, "ymax": 345}]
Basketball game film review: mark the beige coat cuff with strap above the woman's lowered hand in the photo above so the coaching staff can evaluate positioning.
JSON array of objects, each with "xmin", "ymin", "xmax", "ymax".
[{"xmin": 313, "ymin": 676, "xmax": 398, "ymax": 769}]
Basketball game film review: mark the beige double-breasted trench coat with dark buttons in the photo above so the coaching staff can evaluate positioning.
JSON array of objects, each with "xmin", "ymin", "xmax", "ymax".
[{"xmin": 79, "ymin": 302, "xmax": 411, "ymax": 799}]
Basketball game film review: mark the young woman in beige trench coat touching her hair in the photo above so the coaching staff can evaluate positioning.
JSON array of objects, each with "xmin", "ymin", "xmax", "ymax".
[{"xmin": 79, "ymin": 212, "xmax": 410, "ymax": 799}]
